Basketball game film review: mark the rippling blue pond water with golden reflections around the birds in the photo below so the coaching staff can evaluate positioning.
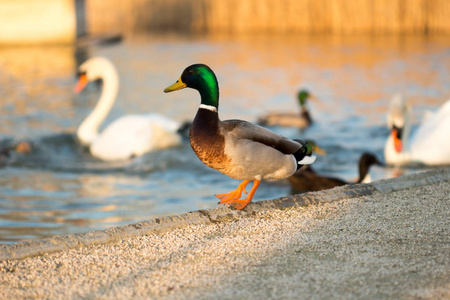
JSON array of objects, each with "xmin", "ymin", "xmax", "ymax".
[{"xmin": 0, "ymin": 36, "xmax": 450, "ymax": 243}]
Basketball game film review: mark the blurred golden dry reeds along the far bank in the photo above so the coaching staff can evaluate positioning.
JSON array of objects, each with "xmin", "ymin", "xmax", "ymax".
[{"xmin": 86, "ymin": 0, "xmax": 450, "ymax": 34}]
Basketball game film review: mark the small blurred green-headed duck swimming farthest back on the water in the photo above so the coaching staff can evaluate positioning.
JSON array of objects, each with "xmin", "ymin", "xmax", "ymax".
[{"xmin": 258, "ymin": 89, "xmax": 312, "ymax": 129}]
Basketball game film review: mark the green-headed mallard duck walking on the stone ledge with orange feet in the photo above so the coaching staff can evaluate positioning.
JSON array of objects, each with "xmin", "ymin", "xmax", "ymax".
[{"xmin": 164, "ymin": 64, "xmax": 316, "ymax": 209}]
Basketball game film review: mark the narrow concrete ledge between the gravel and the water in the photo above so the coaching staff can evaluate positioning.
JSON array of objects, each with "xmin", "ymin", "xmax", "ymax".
[{"xmin": 0, "ymin": 168, "xmax": 450, "ymax": 261}]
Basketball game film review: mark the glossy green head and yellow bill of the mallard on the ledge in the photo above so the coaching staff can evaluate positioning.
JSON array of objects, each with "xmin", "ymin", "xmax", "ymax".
[{"xmin": 164, "ymin": 64, "xmax": 219, "ymax": 108}]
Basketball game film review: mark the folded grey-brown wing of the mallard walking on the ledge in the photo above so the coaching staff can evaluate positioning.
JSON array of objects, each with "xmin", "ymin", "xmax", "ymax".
[{"xmin": 221, "ymin": 120, "xmax": 303, "ymax": 154}]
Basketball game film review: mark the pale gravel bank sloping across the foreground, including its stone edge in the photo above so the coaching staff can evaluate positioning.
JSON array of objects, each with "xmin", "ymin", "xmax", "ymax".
[{"xmin": 0, "ymin": 169, "xmax": 450, "ymax": 299}]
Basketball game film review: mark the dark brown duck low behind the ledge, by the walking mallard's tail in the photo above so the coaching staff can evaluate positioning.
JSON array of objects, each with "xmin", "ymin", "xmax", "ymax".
[{"xmin": 288, "ymin": 153, "xmax": 383, "ymax": 194}]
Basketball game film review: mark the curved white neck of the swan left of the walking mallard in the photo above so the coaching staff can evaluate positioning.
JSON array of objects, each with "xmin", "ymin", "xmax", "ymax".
[{"xmin": 77, "ymin": 71, "xmax": 119, "ymax": 146}]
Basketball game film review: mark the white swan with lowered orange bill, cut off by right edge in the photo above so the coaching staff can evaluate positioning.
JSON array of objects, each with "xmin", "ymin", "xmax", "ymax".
[{"xmin": 384, "ymin": 94, "xmax": 450, "ymax": 165}]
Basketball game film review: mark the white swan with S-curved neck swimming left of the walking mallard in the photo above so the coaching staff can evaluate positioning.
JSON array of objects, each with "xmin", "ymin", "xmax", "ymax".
[{"xmin": 75, "ymin": 57, "xmax": 181, "ymax": 161}]
